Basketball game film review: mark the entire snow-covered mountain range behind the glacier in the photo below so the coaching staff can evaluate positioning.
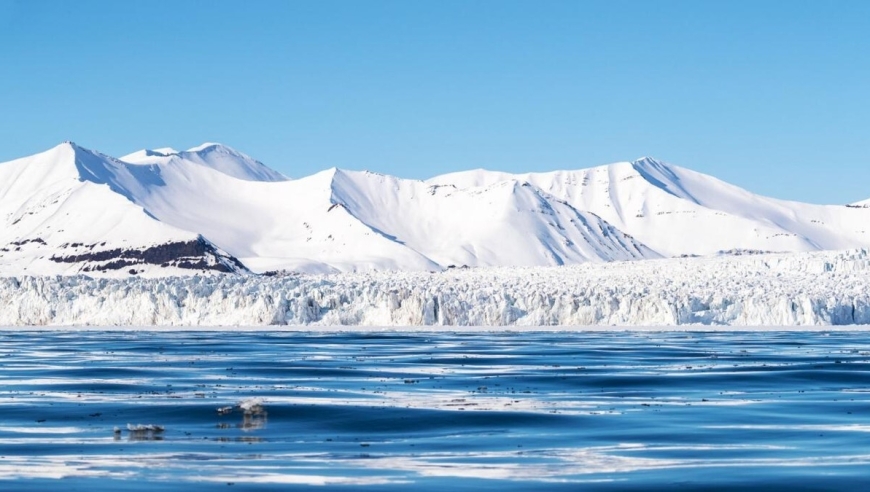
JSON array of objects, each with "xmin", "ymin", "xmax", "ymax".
[{"xmin": 0, "ymin": 142, "xmax": 870, "ymax": 276}]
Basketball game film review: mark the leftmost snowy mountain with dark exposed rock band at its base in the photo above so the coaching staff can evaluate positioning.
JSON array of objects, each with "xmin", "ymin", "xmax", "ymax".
[{"xmin": 0, "ymin": 143, "xmax": 243, "ymax": 275}]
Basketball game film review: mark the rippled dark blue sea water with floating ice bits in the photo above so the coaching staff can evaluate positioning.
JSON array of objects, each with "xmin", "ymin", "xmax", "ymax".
[{"xmin": 0, "ymin": 331, "xmax": 870, "ymax": 492}]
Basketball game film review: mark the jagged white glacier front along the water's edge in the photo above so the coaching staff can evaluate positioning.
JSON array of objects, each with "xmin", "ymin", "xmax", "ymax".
[{"xmin": 0, "ymin": 249, "xmax": 870, "ymax": 327}]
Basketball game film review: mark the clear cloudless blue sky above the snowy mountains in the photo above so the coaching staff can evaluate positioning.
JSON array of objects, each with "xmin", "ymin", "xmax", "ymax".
[{"xmin": 0, "ymin": 0, "xmax": 870, "ymax": 203}]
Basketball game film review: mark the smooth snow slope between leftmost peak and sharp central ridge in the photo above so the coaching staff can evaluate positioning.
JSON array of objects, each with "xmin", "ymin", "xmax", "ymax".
[{"xmin": 117, "ymin": 166, "xmax": 439, "ymax": 272}]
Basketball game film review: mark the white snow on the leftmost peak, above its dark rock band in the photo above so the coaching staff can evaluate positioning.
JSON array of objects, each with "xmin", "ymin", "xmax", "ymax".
[{"xmin": 0, "ymin": 143, "xmax": 213, "ymax": 275}]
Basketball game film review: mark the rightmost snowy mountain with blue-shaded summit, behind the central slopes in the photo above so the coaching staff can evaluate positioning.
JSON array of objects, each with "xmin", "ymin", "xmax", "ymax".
[{"xmin": 428, "ymin": 158, "xmax": 870, "ymax": 256}]
